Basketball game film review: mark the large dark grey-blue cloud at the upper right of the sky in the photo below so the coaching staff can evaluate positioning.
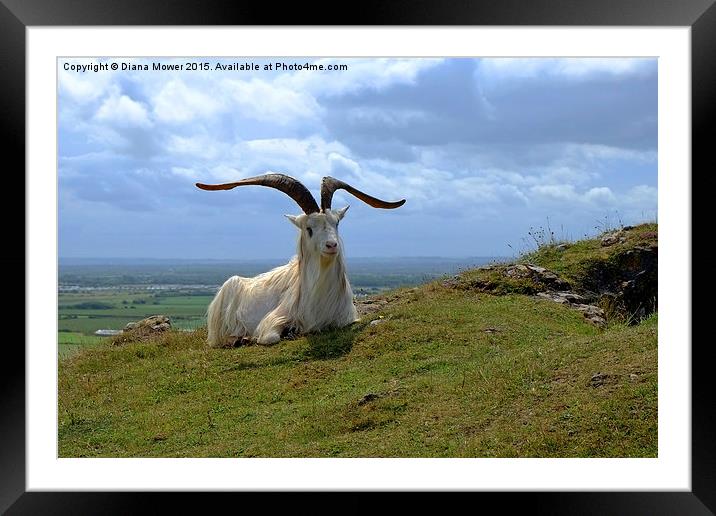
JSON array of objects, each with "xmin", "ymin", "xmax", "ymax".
[{"xmin": 322, "ymin": 59, "xmax": 657, "ymax": 159}]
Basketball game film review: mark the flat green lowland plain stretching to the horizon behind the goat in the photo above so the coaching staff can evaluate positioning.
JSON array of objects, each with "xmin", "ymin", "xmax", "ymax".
[{"xmin": 58, "ymin": 257, "xmax": 504, "ymax": 356}]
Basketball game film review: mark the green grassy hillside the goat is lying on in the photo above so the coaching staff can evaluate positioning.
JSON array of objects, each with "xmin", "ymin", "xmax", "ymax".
[{"xmin": 58, "ymin": 226, "xmax": 657, "ymax": 457}]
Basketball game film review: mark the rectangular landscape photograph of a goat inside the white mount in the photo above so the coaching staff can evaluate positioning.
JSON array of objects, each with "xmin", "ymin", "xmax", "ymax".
[{"xmin": 58, "ymin": 55, "xmax": 665, "ymax": 459}]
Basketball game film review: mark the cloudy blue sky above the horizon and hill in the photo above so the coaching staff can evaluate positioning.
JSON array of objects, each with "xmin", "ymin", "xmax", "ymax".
[{"xmin": 58, "ymin": 58, "xmax": 657, "ymax": 259}]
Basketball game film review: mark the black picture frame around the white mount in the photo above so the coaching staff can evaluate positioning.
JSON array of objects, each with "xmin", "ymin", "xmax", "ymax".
[{"xmin": 0, "ymin": 0, "xmax": 716, "ymax": 514}]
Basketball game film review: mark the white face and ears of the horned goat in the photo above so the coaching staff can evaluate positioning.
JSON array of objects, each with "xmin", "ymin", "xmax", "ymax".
[{"xmin": 286, "ymin": 206, "xmax": 348, "ymax": 259}]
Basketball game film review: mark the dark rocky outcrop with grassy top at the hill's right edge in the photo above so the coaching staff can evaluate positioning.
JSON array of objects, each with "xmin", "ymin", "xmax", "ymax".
[{"xmin": 443, "ymin": 224, "xmax": 658, "ymax": 325}]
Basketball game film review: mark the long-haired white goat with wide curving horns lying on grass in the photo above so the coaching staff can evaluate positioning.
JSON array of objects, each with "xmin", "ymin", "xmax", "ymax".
[{"xmin": 196, "ymin": 173, "xmax": 405, "ymax": 347}]
